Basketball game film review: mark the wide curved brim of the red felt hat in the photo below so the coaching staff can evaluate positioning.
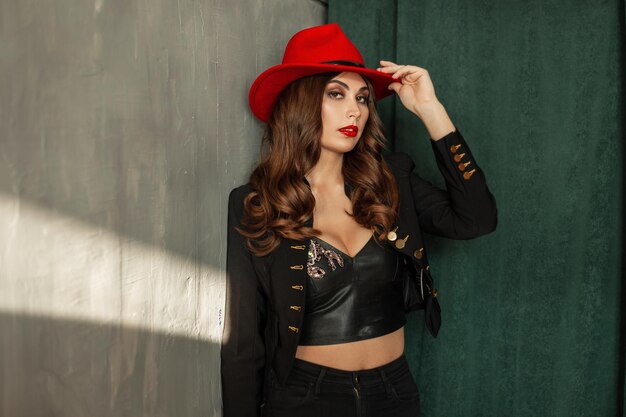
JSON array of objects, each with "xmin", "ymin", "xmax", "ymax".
[{"xmin": 248, "ymin": 63, "xmax": 400, "ymax": 122}]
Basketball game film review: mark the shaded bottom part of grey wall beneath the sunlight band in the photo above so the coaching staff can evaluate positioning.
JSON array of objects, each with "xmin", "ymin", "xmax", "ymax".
[{"xmin": 0, "ymin": 312, "xmax": 221, "ymax": 417}]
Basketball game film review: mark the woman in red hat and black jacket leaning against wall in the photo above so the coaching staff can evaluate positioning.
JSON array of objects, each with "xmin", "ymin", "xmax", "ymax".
[{"xmin": 222, "ymin": 24, "xmax": 496, "ymax": 417}]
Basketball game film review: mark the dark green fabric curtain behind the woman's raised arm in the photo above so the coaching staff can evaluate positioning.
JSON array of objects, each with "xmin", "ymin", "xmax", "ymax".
[{"xmin": 328, "ymin": 0, "xmax": 626, "ymax": 417}]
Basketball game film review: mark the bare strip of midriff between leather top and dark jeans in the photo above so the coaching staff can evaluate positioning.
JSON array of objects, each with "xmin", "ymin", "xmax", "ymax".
[{"xmin": 296, "ymin": 326, "xmax": 404, "ymax": 371}]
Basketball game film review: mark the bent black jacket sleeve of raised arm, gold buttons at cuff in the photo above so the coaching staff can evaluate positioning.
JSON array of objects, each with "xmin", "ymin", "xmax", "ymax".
[{"xmin": 398, "ymin": 129, "xmax": 498, "ymax": 239}]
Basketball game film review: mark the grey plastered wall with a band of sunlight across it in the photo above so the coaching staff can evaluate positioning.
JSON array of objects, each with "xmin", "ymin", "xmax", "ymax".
[{"xmin": 0, "ymin": 0, "xmax": 326, "ymax": 417}]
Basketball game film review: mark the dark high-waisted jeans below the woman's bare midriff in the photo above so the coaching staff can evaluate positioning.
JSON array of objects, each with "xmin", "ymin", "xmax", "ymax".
[{"xmin": 266, "ymin": 354, "xmax": 420, "ymax": 417}]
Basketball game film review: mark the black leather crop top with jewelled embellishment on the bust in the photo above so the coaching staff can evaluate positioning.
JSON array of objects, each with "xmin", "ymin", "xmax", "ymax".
[{"xmin": 299, "ymin": 236, "xmax": 406, "ymax": 345}]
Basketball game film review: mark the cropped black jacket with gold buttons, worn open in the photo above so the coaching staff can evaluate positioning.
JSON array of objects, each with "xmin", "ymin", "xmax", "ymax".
[{"xmin": 221, "ymin": 130, "xmax": 497, "ymax": 417}]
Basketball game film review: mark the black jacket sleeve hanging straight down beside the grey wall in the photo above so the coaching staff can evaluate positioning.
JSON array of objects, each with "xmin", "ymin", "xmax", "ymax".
[{"xmin": 221, "ymin": 186, "xmax": 267, "ymax": 417}]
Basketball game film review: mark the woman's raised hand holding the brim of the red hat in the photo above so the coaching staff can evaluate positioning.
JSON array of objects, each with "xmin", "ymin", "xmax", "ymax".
[{"xmin": 377, "ymin": 60, "xmax": 439, "ymax": 117}]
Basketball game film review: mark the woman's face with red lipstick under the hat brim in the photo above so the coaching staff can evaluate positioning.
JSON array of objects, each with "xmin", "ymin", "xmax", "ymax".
[{"xmin": 321, "ymin": 72, "xmax": 370, "ymax": 153}]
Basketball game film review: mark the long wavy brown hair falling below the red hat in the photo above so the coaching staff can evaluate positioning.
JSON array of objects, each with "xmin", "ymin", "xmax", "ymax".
[{"xmin": 237, "ymin": 72, "xmax": 398, "ymax": 256}]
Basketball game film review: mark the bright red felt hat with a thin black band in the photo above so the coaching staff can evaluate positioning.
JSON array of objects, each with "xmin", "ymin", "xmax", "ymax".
[{"xmin": 248, "ymin": 23, "xmax": 398, "ymax": 122}]
